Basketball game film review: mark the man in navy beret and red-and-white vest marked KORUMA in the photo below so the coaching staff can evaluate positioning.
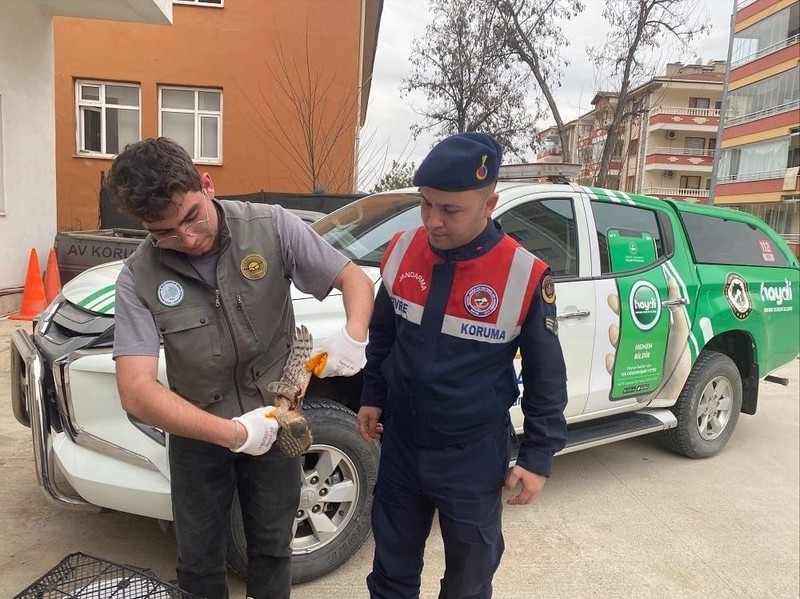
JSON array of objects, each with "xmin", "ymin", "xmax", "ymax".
[{"xmin": 358, "ymin": 133, "xmax": 567, "ymax": 599}]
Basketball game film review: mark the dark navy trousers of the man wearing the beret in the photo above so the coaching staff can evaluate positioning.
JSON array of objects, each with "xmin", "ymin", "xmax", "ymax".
[{"xmin": 367, "ymin": 420, "xmax": 511, "ymax": 599}]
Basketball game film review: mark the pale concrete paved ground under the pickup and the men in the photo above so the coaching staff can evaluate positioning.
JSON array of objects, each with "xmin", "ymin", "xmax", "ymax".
[{"xmin": 0, "ymin": 320, "xmax": 800, "ymax": 599}]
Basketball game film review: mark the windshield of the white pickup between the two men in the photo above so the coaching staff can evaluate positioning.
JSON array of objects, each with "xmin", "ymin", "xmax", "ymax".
[{"xmin": 312, "ymin": 193, "xmax": 422, "ymax": 266}]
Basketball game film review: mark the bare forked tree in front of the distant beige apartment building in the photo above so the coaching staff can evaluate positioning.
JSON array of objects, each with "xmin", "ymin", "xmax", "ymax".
[{"xmin": 587, "ymin": 0, "xmax": 711, "ymax": 187}]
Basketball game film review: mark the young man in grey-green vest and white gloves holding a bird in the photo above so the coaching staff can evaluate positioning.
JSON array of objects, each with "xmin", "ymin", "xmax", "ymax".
[{"xmin": 106, "ymin": 138, "xmax": 373, "ymax": 599}]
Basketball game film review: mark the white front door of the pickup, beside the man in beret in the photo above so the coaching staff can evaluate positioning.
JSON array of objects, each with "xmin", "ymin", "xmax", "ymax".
[{"xmin": 494, "ymin": 189, "xmax": 595, "ymax": 422}]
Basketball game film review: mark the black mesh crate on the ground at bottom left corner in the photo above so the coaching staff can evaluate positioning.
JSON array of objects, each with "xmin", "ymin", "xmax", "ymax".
[{"xmin": 14, "ymin": 553, "xmax": 199, "ymax": 599}]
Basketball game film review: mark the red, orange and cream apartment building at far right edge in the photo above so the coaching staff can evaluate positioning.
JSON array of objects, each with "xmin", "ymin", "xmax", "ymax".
[{"xmin": 714, "ymin": 0, "xmax": 800, "ymax": 255}]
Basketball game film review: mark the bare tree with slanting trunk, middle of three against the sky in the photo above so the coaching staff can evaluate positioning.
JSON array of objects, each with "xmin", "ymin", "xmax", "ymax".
[{"xmin": 484, "ymin": 0, "xmax": 584, "ymax": 162}]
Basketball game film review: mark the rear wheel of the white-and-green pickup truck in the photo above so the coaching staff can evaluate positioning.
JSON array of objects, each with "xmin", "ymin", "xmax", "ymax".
[{"xmin": 664, "ymin": 351, "xmax": 742, "ymax": 458}]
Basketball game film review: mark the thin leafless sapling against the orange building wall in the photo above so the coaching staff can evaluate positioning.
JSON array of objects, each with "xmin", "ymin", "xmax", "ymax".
[{"xmin": 239, "ymin": 31, "xmax": 358, "ymax": 193}]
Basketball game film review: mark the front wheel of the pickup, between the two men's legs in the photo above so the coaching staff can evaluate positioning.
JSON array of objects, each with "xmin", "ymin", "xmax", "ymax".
[{"xmin": 228, "ymin": 397, "xmax": 380, "ymax": 583}]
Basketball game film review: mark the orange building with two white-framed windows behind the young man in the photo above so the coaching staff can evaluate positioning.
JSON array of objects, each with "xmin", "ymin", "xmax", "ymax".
[{"xmin": 54, "ymin": 0, "xmax": 383, "ymax": 230}]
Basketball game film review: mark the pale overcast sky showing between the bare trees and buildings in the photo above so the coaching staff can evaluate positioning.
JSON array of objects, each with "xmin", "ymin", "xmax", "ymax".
[{"xmin": 360, "ymin": 0, "xmax": 734, "ymax": 191}]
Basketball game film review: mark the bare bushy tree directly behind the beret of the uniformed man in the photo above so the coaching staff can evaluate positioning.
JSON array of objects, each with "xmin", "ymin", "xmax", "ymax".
[{"xmin": 401, "ymin": 0, "xmax": 539, "ymax": 158}]
